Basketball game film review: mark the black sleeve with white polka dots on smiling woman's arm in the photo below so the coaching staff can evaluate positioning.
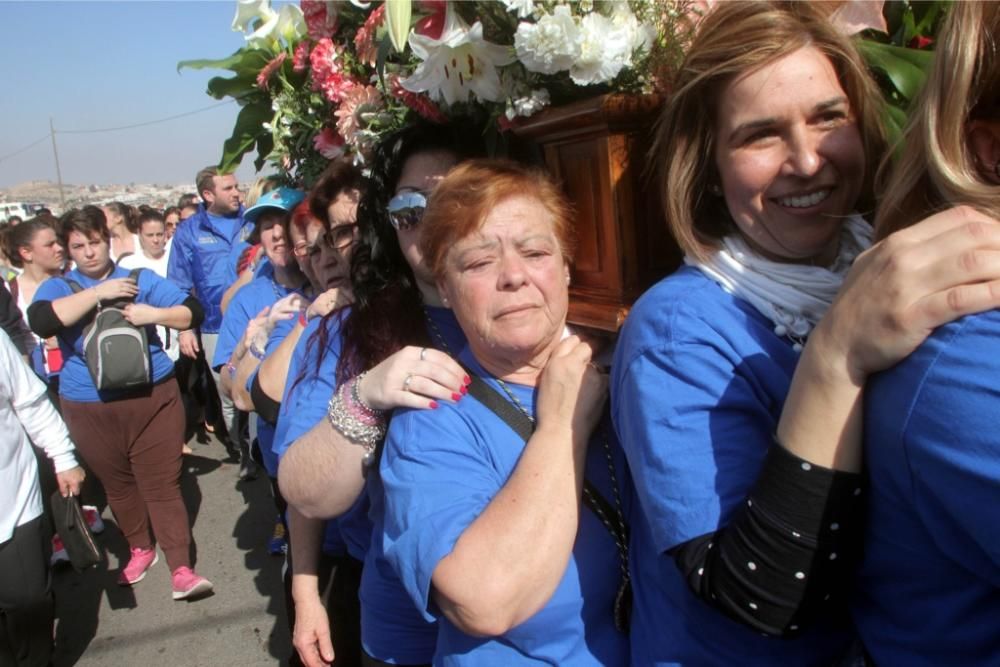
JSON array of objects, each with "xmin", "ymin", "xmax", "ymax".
[{"xmin": 669, "ymin": 443, "xmax": 863, "ymax": 636}]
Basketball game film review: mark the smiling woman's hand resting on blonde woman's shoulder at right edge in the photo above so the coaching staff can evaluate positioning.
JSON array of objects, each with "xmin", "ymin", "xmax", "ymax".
[{"xmin": 810, "ymin": 206, "xmax": 1000, "ymax": 385}]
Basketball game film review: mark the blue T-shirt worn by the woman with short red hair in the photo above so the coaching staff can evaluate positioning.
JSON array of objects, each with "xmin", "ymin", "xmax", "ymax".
[{"xmin": 381, "ymin": 350, "xmax": 629, "ymax": 667}]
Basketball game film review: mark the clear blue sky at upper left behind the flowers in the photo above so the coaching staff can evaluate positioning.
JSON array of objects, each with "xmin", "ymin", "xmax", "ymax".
[{"xmin": 0, "ymin": 0, "xmax": 277, "ymax": 188}]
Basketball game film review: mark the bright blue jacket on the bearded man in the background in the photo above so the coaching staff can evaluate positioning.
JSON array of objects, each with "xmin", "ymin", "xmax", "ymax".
[{"xmin": 167, "ymin": 205, "xmax": 253, "ymax": 333}]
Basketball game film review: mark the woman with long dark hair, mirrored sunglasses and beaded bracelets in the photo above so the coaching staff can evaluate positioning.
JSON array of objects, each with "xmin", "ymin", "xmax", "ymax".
[{"xmin": 274, "ymin": 122, "xmax": 482, "ymax": 666}]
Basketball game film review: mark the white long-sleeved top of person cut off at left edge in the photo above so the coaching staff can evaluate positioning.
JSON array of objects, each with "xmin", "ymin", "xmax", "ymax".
[{"xmin": 0, "ymin": 330, "xmax": 77, "ymax": 544}]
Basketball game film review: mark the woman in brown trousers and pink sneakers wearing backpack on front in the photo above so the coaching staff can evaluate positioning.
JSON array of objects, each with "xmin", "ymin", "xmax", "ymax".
[{"xmin": 28, "ymin": 206, "xmax": 212, "ymax": 600}]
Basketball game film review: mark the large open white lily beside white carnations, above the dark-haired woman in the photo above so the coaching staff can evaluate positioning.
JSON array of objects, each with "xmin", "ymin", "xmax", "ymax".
[{"xmin": 400, "ymin": 2, "xmax": 515, "ymax": 105}]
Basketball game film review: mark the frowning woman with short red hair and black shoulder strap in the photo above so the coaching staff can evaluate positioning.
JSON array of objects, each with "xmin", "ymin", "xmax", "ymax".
[{"xmin": 381, "ymin": 160, "xmax": 629, "ymax": 667}]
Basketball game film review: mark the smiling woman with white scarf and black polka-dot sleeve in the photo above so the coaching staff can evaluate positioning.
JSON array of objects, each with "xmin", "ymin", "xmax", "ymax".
[{"xmin": 611, "ymin": 2, "xmax": 1000, "ymax": 665}]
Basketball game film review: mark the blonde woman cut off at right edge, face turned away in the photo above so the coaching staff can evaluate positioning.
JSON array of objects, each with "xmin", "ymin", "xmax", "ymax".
[{"xmin": 853, "ymin": 2, "xmax": 1000, "ymax": 665}]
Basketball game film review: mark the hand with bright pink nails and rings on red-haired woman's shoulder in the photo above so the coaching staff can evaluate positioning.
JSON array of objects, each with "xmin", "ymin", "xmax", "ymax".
[{"xmin": 358, "ymin": 345, "xmax": 467, "ymax": 410}]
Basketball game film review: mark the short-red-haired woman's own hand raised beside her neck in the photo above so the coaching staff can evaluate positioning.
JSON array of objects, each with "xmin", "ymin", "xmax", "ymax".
[{"xmin": 537, "ymin": 336, "xmax": 608, "ymax": 442}]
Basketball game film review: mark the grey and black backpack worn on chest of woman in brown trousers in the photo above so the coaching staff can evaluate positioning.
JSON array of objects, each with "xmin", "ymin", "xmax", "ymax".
[{"xmin": 65, "ymin": 269, "xmax": 153, "ymax": 391}]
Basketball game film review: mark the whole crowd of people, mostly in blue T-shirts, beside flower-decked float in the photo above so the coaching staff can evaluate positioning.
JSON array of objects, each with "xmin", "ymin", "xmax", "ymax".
[{"xmin": 0, "ymin": 2, "xmax": 1000, "ymax": 667}]
